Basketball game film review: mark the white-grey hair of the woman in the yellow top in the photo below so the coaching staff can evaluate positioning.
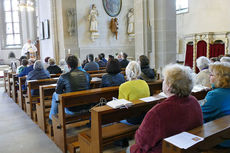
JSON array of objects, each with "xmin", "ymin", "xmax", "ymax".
[{"xmin": 125, "ymin": 61, "xmax": 141, "ymax": 81}]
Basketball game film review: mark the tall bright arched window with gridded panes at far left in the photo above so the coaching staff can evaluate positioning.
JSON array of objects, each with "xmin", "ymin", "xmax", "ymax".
[{"xmin": 0, "ymin": 0, "xmax": 22, "ymax": 49}]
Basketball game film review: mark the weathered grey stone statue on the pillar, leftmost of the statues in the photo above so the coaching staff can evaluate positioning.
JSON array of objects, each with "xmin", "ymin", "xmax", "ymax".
[{"xmin": 67, "ymin": 8, "xmax": 76, "ymax": 36}]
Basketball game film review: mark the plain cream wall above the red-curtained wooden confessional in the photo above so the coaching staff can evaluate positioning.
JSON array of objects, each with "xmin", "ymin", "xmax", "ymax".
[{"xmin": 177, "ymin": 0, "xmax": 230, "ymax": 56}]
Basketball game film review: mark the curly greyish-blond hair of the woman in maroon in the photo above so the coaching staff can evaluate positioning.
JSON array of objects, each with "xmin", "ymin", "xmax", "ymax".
[{"xmin": 163, "ymin": 64, "xmax": 195, "ymax": 97}]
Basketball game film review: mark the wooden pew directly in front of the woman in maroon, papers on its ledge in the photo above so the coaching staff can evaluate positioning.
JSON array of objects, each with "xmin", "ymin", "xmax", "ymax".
[{"xmin": 78, "ymin": 91, "xmax": 207, "ymax": 153}]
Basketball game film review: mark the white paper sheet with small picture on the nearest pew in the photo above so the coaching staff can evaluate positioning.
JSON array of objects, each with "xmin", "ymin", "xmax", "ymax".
[{"xmin": 164, "ymin": 132, "xmax": 204, "ymax": 149}]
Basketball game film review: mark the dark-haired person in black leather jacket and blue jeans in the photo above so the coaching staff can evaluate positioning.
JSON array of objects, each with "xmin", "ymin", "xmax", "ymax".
[{"xmin": 49, "ymin": 55, "xmax": 91, "ymax": 123}]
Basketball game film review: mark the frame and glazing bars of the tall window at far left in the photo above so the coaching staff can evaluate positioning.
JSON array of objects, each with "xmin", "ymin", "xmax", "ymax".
[{"xmin": 0, "ymin": 0, "xmax": 23, "ymax": 50}]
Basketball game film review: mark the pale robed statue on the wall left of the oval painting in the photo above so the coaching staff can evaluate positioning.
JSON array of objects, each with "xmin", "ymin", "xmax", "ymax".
[{"xmin": 88, "ymin": 4, "xmax": 99, "ymax": 41}]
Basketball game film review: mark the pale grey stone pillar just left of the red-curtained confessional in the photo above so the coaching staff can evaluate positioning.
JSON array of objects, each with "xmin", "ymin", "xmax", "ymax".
[{"xmin": 151, "ymin": 0, "xmax": 177, "ymax": 69}]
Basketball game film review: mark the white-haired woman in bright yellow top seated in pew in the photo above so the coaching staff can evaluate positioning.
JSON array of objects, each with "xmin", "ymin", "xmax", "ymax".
[{"xmin": 118, "ymin": 61, "xmax": 150, "ymax": 124}]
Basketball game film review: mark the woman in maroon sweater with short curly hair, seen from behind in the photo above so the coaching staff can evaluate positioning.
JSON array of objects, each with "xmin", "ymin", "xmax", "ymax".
[{"xmin": 127, "ymin": 64, "xmax": 203, "ymax": 153}]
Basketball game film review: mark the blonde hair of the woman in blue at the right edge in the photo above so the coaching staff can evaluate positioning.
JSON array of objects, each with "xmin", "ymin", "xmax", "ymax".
[{"xmin": 209, "ymin": 62, "xmax": 230, "ymax": 88}]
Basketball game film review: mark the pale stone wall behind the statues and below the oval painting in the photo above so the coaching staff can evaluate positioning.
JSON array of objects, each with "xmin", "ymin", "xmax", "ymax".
[{"xmin": 76, "ymin": 0, "xmax": 135, "ymax": 59}]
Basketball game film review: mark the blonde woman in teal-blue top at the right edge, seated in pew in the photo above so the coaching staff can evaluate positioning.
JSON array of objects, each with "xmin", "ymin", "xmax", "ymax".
[{"xmin": 201, "ymin": 62, "xmax": 230, "ymax": 148}]
